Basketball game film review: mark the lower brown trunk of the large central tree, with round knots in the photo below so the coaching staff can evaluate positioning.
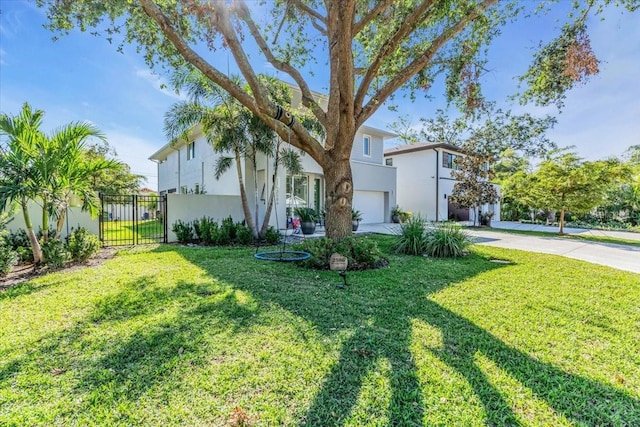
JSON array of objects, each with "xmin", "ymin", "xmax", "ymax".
[{"xmin": 323, "ymin": 156, "xmax": 353, "ymax": 241}]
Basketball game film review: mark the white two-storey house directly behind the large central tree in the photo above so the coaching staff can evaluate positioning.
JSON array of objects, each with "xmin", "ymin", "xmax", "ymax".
[{"xmin": 149, "ymin": 87, "xmax": 396, "ymax": 228}]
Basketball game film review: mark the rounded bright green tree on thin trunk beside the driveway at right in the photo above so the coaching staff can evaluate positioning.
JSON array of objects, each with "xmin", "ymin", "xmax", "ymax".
[{"xmin": 528, "ymin": 151, "xmax": 628, "ymax": 234}]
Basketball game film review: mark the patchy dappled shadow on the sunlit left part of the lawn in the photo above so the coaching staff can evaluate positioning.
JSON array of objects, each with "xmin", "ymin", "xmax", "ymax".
[{"xmin": 0, "ymin": 275, "xmax": 264, "ymax": 424}]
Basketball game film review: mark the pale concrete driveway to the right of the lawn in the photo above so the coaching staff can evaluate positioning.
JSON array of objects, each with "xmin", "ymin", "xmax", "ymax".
[{"xmin": 358, "ymin": 222, "xmax": 640, "ymax": 273}]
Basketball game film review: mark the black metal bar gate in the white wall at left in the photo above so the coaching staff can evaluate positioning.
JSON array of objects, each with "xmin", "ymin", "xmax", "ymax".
[{"xmin": 100, "ymin": 194, "xmax": 167, "ymax": 246}]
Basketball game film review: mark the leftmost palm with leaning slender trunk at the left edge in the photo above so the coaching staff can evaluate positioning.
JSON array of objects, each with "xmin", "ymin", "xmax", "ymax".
[{"xmin": 0, "ymin": 103, "xmax": 44, "ymax": 264}]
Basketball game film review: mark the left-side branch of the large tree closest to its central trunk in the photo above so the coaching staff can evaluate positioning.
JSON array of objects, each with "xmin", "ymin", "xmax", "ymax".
[{"xmin": 239, "ymin": 0, "xmax": 327, "ymax": 128}]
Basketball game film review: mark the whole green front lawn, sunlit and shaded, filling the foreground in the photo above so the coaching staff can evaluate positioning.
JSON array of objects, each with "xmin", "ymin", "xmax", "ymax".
[{"xmin": 0, "ymin": 236, "xmax": 640, "ymax": 426}]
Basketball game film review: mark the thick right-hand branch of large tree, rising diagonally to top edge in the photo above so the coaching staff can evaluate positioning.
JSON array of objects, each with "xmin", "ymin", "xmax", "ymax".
[{"xmin": 356, "ymin": 0, "xmax": 498, "ymax": 126}]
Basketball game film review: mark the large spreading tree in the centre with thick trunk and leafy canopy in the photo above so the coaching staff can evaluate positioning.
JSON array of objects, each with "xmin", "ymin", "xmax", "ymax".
[{"xmin": 38, "ymin": 0, "xmax": 637, "ymax": 240}]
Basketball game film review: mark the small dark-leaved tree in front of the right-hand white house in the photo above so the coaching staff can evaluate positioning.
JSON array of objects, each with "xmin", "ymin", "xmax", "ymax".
[{"xmin": 449, "ymin": 143, "xmax": 498, "ymax": 226}]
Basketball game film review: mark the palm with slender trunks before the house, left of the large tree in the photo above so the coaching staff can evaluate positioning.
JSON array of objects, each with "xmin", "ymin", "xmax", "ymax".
[{"xmin": 165, "ymin": 70, "xmax": 301, "ymax": 238}]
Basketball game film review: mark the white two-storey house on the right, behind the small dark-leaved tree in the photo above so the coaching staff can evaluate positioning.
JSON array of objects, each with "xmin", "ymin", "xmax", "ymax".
[{"xmin": 384, "ymin": 143, "xmax": 500, "ymax": 221}]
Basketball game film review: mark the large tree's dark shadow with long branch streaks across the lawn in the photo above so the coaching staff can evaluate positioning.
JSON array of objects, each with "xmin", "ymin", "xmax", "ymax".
[{"xmin": 175, "ymin": 246, "xmax": 640, "ymax": 425}]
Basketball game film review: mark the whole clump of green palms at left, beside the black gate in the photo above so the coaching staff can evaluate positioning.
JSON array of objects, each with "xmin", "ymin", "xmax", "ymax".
[{"xmin": 0, "ymin": 103, "xmax": 119, "ymax": 264}]
